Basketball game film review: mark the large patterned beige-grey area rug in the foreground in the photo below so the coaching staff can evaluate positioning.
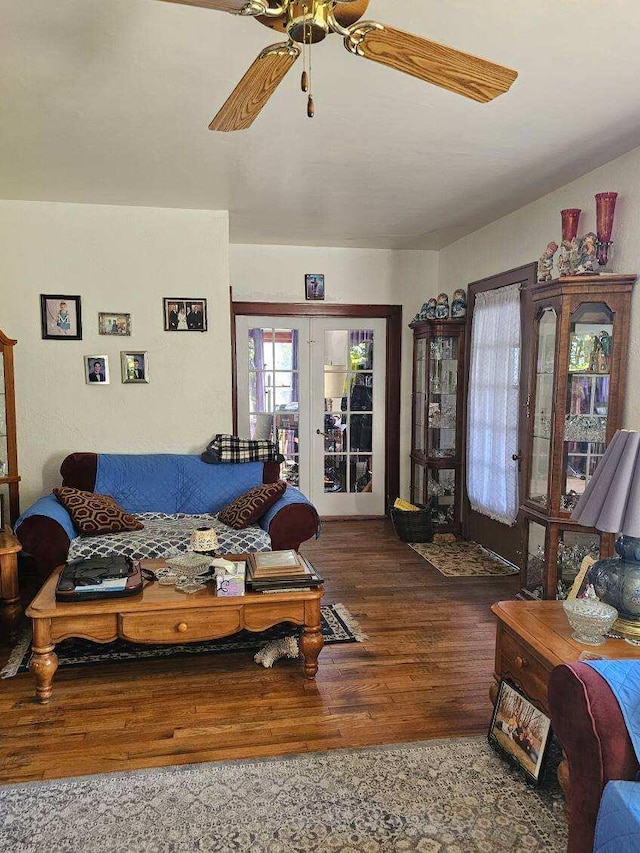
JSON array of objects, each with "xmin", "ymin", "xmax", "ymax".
[{"xmin": 0, "ymin": 737, "xmax": 567, "ymax": 853}]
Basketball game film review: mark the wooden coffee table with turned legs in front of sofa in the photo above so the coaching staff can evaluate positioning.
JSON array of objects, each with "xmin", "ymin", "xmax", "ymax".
[{"xmin": 26, "ymin": 555, "xmax": 324, "ymax": 704}]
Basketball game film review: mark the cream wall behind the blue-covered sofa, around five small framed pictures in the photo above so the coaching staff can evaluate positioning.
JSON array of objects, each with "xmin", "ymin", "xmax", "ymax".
[{"xmin": 0, "ymin": 201, "xmax": 231, "ymax": 508}]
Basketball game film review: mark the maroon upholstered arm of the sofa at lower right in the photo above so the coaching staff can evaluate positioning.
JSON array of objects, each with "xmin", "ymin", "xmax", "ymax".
[{"xmin": 549, "ymin": 661, "xmax": 640, "ymax": 853}]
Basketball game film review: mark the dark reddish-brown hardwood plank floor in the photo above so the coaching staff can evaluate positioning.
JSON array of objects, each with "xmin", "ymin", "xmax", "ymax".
[{"xmin": 0, "ymin": 521, "xmax": 518, "ymax": 782}]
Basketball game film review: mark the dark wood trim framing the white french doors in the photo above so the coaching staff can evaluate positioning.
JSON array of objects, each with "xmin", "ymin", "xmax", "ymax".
[{"xmin": 231, "ymin": 295, "xmax": 402, "ymax": 511}]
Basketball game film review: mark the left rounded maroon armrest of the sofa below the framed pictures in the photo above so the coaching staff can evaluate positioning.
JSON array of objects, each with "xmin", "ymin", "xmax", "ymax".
[{"xmin": 14, "ymin": 495, "xmax": 78, "ymax": 577}]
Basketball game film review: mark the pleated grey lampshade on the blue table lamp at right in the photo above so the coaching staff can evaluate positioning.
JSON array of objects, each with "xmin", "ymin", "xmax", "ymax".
[{"xmin": 571, "ymin": 429, "xmax": 640, "ymax": 538}]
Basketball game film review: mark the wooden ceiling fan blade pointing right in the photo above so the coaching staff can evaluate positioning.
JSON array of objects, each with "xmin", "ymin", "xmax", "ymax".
[{"xmin": 344, "ymin": 21, "xmax": 518, "ymax": 103}]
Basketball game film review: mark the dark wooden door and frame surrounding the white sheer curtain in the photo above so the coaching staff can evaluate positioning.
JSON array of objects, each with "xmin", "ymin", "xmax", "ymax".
[{"xmin": 462, "ymin": 263, "xmax": 538, "ymax": 566}]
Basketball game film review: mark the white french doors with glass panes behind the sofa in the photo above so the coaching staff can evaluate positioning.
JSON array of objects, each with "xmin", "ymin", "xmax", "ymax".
[{"xmin": 236, "ymin": 316, "xmax": 386, "ymax": 516}]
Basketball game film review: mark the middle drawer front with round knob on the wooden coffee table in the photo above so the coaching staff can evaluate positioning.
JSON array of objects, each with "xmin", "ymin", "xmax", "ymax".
[{"xmin": 118, "ymin": 607, "xmax": 242, "ymax": 643}]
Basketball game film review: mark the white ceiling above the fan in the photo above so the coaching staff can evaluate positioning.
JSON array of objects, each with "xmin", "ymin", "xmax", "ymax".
[{"xmin": 0, "ymin": 0, "xmax": 640, "ymax": 248}]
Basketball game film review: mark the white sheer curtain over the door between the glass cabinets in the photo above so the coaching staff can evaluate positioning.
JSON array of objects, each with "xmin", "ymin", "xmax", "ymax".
[{"xmin": 467, "ymin": 284, "xmax": 520, "ymax": 525}]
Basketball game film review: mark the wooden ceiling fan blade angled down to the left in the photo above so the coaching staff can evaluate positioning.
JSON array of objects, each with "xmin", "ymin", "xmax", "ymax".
[{"xmin": 209, "ymin": 42, "xmax": 300, "ymax": 131}]
